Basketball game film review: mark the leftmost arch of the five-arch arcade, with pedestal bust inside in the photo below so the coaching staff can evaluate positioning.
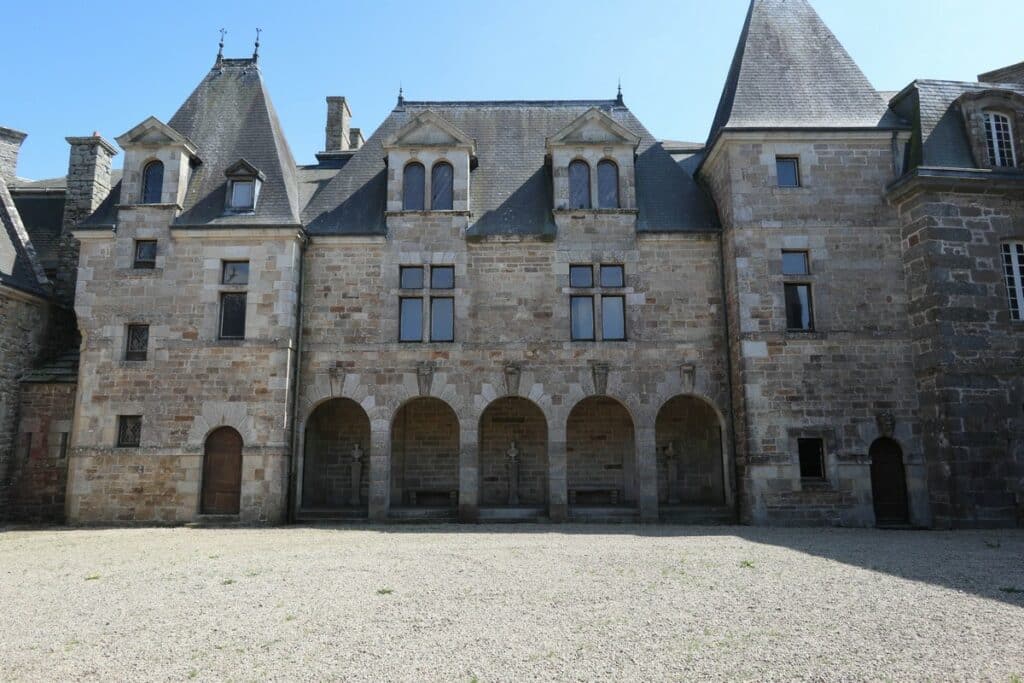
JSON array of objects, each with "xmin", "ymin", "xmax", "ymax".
[{"xmin": 302, "ymin": 398, "xmax": 370, "ymax": 510}]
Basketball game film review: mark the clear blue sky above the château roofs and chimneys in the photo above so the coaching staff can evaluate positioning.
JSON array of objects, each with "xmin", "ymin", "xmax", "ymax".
[{"xmin": 0, "ymin": 0, "xmax": 1024, "ymax": 178}]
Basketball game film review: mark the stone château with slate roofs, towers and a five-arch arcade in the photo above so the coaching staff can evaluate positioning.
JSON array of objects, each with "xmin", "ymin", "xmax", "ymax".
[{"xmin": 0, "ymin": 0, "xmax": 1024, "ymax": 527}]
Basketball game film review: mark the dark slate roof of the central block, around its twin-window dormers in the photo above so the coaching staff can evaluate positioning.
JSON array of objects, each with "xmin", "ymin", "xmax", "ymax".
[{"xmin": 300, "ymin": 99, "xmax": 718, "ymax": 237}]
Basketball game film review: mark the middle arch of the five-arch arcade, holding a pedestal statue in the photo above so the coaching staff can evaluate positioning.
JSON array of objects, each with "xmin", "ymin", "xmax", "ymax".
[{"xmin": 480, "ymin": 396, "xmax": 548, "ymax": 507}]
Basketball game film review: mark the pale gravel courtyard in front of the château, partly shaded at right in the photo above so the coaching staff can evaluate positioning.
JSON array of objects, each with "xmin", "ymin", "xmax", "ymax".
[{"xmin": 0, "ymin": 525, "xmax": 1024, "ymax": 682}]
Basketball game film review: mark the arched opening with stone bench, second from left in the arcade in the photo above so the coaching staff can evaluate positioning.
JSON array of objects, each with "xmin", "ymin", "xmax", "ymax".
[{"xmin": 391, "ymin": 396, "xmax": 459, "ymax": 508}]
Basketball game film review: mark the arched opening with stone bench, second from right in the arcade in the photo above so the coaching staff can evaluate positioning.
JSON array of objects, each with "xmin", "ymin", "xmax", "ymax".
[{"xmin": 565, "ymin": 396, "xmax": 637, "ymax": 507}]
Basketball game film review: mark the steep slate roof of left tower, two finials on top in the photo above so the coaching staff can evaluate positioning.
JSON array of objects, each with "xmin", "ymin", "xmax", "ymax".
[{"xmin": 168, "ymin": 59, "xmax": 299, "ymax": 226}]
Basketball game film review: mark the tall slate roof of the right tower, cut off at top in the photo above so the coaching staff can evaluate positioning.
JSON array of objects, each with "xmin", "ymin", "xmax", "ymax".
[{"xmin": 708, "ymin": 0, "xmax": 904, "ymax": 146}]
